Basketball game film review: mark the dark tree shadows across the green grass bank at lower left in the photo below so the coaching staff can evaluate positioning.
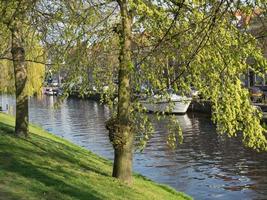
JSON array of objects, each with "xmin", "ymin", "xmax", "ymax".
[{"xmin": 0, "ymin": 122, "xmax": 109, "ymax": 200}]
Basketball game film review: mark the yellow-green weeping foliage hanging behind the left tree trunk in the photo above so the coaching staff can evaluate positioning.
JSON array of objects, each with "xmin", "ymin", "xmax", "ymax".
[{"xmin": 0, "ymin": 1, "xmax": 45, "ymax": 95}]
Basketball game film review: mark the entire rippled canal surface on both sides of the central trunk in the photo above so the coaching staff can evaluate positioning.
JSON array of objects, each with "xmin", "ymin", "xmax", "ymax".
[{"xmin": 0, "ymin": 96, "xmax": 267, "ymax": 200}]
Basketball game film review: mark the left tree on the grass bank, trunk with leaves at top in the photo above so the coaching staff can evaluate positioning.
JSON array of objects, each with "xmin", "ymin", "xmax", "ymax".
[{"xmin": 0, "ymin": 0, "xmax": 45, "ymax": 136}]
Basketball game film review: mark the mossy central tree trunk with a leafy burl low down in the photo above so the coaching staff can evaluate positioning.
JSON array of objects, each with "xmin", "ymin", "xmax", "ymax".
[{"xmin": 113, "ymin": 0, "xmax": 134, "ymax": 184}]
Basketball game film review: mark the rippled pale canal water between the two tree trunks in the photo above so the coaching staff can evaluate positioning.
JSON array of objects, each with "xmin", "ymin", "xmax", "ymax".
[{"xmin": 31, "ymin": 96, "xmax": 111, "ymax": 158}]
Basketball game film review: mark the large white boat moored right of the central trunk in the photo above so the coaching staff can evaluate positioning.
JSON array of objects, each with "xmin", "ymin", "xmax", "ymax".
[{"xmin": 140, "ymin": 94, "xmax": 192, "ymax": 114}]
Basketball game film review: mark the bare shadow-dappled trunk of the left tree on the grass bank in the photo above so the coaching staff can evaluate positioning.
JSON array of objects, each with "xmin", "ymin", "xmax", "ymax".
[{"xmin": 10, "ymin": 24, "xmax": 29, "ymax": 136}]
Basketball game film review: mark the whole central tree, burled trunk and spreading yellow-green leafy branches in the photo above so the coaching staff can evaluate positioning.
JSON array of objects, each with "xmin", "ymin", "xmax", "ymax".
[{"xmin": 38, "ymin": 0, "xmax": 267, "ymax": 184}]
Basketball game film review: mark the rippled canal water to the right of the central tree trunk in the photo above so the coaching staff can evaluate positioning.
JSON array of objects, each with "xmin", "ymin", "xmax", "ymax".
[{"xmin": 141, "ymin": 115, "xmax": 267, "ymax": 199}]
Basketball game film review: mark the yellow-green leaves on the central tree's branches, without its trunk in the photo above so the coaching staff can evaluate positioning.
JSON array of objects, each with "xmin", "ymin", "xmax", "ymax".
[{"xmin": 39, "ymin": 0, "xmax": 266, "ymax": 150}]
